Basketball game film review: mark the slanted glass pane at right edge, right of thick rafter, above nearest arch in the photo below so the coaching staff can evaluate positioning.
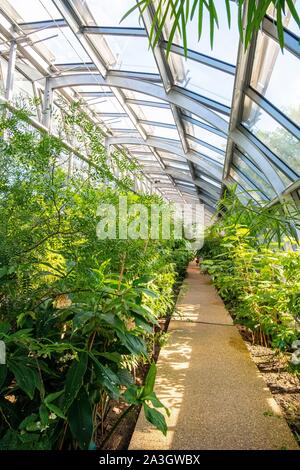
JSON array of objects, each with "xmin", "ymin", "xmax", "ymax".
[{"xmin": 243, "ymin": 97, "xmax": 300, "ymax": 174}]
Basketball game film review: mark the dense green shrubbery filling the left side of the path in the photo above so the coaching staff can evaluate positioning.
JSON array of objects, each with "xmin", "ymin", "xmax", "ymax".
[{"xmin": 0, "ymin": 108, "xmax": 189, "ymax": 449}]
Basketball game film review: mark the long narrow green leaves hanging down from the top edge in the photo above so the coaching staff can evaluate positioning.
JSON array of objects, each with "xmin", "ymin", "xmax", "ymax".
[{"xmin": 121, "ymin": 0, "xmax": 300, "ymax": 55}]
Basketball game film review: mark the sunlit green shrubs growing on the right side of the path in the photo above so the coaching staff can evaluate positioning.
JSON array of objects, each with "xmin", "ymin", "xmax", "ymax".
[{"xmin": 201, "ymin": 185, "xmax": 300, "ymax": 349}]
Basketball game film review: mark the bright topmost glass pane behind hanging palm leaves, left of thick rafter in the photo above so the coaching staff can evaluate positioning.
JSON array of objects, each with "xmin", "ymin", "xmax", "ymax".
[{"xmin": 169, "ymin": 0, "xmax": 239, "ymax": 64}]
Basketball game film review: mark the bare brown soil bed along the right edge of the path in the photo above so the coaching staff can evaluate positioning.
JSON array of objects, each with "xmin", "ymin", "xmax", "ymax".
[{"xmin": 236, "ymin": 325, "xmax": 300, "ymax": 446}]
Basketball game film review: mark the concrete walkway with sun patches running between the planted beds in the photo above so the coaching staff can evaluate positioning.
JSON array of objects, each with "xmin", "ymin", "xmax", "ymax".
[{"xmin": 129, "ymin": 263, "xmax": 298, "ymax": 450}]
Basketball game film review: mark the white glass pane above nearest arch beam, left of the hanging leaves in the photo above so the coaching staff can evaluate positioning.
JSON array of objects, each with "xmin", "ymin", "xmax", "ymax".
[{"xmin": 103, "ymin": 35, "xmax": 158, "ymax": 73}]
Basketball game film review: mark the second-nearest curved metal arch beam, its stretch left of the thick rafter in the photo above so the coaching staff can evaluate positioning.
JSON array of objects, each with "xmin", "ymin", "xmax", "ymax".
[{"xmin": 105, "ymin": 135, "xmax": 222, "ymax": 179}]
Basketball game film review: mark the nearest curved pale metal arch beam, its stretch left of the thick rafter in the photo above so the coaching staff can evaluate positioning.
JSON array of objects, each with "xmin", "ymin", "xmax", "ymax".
[{"xmin": 49, "ymin": 73, "xmax": 228, "ymax": 133}]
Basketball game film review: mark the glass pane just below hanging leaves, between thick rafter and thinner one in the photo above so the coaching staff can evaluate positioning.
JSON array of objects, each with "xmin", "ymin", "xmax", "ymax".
[{"xmin": 170, "ymin": 52, "xmax": 234, "ymax": 106}]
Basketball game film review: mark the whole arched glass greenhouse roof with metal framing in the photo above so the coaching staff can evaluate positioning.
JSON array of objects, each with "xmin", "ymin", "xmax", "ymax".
[{"xmin": 0, "ymin": 0, "xmax": 300, "ymax": 211}]
